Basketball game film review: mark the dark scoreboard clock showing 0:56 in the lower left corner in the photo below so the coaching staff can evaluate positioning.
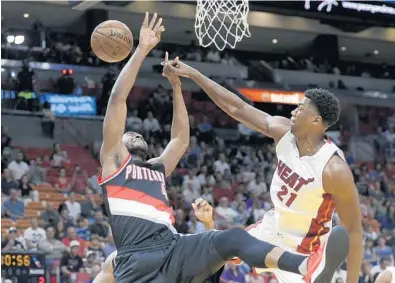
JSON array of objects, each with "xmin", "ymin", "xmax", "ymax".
[{"xmin": 1, "ymin": 251, "xmax": 46, "ymax": 283}]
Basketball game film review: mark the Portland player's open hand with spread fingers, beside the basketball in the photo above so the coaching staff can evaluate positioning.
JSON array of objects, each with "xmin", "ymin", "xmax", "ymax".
[{"xmin": 139, "ymin": 12, "xmax": 165, "ymax": 51}]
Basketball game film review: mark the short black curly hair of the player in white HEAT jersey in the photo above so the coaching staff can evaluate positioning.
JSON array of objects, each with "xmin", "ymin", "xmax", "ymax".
[{"xmin": 304, "ymin": 88, "xmax": 340, "ymax": 127}]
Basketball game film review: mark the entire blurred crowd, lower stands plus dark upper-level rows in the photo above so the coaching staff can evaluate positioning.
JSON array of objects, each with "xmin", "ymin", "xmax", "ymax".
[{"xmin": 1, "ymin": 21, "xmax": 395, "ymax": 283}]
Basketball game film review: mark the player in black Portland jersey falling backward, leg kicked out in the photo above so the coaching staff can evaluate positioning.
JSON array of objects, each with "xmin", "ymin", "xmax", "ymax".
[{"xmin": 98, "ymin": 13, "xmax": 348, "ymax": 283}]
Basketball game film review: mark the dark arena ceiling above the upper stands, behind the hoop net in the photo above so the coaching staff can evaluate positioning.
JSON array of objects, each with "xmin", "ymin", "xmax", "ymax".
[{"xmin": 2, "ymin": 1, "xmax": 395, "ymax": 64}]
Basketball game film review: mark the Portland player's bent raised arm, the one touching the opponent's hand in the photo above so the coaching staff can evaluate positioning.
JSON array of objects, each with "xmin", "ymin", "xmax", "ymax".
[{"xmin": 148, "ymin": 52, "xmax": 190, "ymax": 176}]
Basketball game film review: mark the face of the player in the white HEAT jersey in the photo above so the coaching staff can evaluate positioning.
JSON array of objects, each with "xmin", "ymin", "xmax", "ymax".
[{"xmin": 291, "ymin": 97, "xmax": 322, "ymax": 134}]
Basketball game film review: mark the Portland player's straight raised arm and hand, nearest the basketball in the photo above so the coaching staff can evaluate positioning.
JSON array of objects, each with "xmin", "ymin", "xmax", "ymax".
[{"xmin": 100, "ymin": 13, "xmax": 164, "ymax": 163}]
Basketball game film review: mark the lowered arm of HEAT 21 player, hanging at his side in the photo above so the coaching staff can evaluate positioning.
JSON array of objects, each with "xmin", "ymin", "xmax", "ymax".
[{"xmin": 323, "ymin": 155, "xmax": 363, "ymax": 283}]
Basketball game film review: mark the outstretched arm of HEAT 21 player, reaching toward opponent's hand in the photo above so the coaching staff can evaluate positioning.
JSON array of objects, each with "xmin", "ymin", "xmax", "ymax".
[{"xmin": 164, "ymin": 60, "xmax": 290, "ymax": 142}]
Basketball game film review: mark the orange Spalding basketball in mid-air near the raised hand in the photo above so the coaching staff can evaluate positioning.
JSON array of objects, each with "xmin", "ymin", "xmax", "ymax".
[{"xmin": 91, "ymin": 20, "xmax": 133, "ymax": 63}]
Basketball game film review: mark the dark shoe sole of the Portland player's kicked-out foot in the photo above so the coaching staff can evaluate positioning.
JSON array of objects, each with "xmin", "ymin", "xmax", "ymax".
[{"xmin": 312, "ymin": 226, "xmax": 350, "ymax": 283}]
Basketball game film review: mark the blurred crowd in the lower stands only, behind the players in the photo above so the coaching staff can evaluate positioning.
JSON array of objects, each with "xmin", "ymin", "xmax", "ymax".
[{"xmin": 1, "ymin": 91, "xmax": 395, "ymax": 283}]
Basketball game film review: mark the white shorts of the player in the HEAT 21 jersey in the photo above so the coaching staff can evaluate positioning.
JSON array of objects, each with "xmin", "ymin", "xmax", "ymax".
[{"xmin": 247, "ymin": 210, "xmax": 305, "ymax": 283}]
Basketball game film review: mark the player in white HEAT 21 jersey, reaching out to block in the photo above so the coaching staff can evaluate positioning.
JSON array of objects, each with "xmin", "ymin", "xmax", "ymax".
[{"xmin": 165, "ymin": 59, "xmax": 363, "ymax": 283}]
